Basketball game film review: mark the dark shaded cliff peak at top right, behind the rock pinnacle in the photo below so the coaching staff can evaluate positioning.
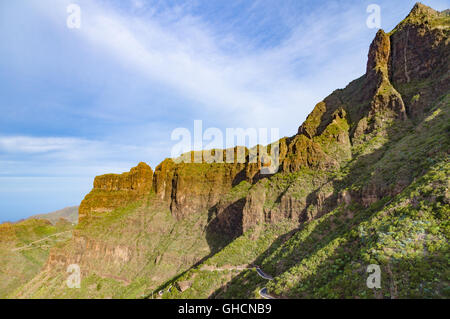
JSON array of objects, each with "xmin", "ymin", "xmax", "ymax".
[{"xmin": 389, "ymin": 3, "xmax": 450, "ymax": 120}]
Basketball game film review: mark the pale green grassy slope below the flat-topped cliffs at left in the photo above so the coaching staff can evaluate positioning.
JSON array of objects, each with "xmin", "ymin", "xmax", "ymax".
[{"xmin": 11, "ymin": 195, "xmax": 232, "ymax": 298}]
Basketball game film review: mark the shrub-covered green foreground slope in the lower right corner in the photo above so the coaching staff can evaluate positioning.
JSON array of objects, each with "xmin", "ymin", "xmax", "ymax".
[{"xmin": 263, "ymin": 161, "xmax": 450, "ymax": 298}]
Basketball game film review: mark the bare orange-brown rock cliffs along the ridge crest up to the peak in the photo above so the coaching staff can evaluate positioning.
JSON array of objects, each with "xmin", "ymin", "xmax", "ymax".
[{"xmin": 76, "ymin": 4, "xmax": 450, "ymax": 235}]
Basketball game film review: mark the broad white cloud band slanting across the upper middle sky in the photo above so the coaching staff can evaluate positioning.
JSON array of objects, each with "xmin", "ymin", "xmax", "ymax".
[{"xmin": 30, "ymin": 1, "xmax": 370, "ymax": 134}]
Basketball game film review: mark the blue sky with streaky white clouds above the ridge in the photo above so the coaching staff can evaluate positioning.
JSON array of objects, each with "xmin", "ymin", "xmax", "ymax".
[{"xmin": 0, "ymin": 0, "xmax": 450, "ymax": 222}]
